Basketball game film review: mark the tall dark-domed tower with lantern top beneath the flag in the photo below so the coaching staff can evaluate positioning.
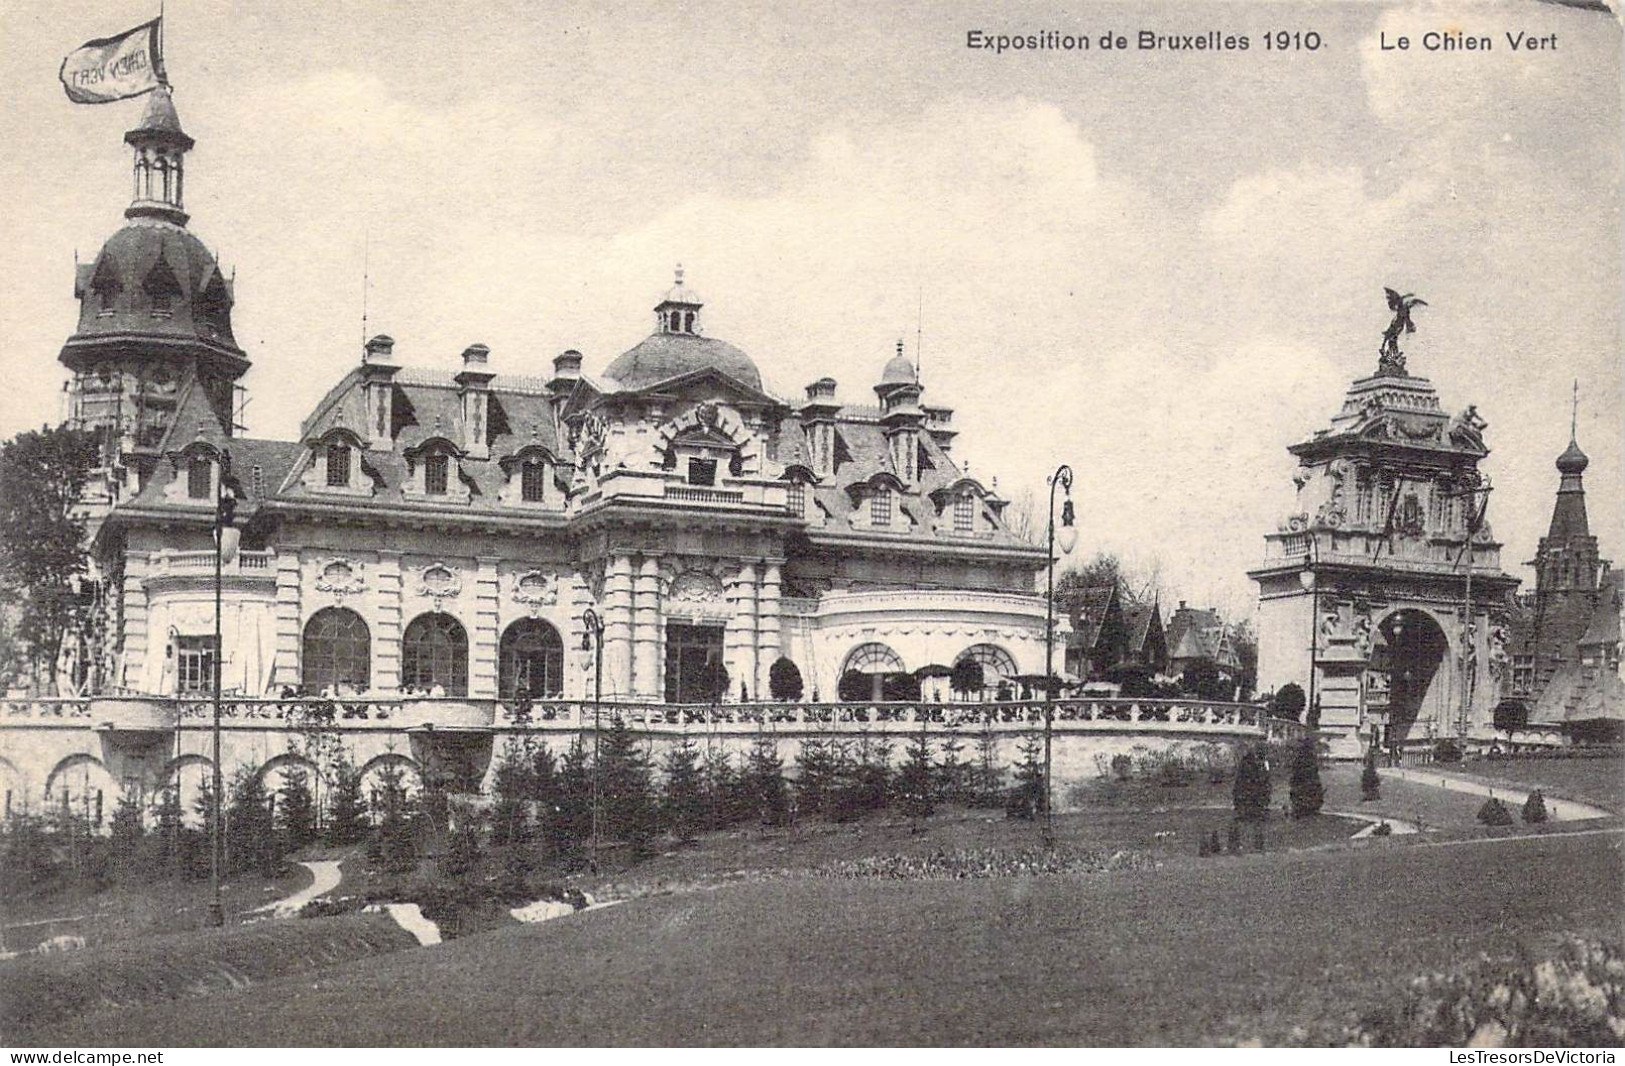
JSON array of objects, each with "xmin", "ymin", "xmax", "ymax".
[{"xmin": 59, "ymin": 86, "xmax": 249, "ymax": 492}]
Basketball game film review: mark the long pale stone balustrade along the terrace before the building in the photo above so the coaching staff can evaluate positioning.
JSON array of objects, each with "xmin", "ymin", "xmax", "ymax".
[{"xmin": 0, "ymin": 696, "xmax": 1303, "ymax": 739}]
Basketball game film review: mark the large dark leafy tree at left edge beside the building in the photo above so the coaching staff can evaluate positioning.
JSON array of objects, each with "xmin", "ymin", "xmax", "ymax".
[{"xmin": 0, "ymin": 426, "xmax": 96, "ymax": 691}]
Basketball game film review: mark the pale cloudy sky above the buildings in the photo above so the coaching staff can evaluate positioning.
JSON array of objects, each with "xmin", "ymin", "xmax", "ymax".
[{"xmin": 0, "ymin": 0, "xmax": 1625, "ymax": 613}]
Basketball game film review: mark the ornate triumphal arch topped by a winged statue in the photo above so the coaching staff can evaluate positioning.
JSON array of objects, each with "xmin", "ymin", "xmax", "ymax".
[{"xmin": 1248, "ymin": 291, "xmax": 1518, "ymax": 756}]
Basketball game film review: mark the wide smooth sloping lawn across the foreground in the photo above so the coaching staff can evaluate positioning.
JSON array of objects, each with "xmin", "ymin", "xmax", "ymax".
[{"xmin": 39, "ymin": 830, "xmax": 1625, "ymax": 1047}]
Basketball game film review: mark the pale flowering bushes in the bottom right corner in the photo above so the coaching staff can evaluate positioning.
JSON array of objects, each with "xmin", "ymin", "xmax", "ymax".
[{"xmin": 1350, "ymin": 938, "xmax": 1625, "ymax": 1048}]
